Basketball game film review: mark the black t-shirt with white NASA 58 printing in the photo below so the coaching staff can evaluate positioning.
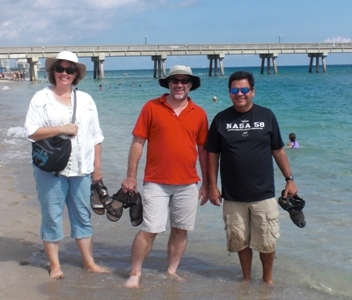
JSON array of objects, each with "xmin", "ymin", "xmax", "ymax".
[{"xmin": 205, "ymin": 104, "xmax": 284, "ymax": 202}]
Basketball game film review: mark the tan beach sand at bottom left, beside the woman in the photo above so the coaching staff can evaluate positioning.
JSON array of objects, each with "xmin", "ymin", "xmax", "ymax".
[{"xmin": 0, "ymin": 166, "xmax": 50, "ymax": 300}]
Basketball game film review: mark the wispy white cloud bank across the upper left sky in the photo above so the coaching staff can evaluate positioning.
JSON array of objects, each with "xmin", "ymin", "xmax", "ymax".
[{"xmin": 0, "ymin": 0, "xmax": 200, "ymax": 46}]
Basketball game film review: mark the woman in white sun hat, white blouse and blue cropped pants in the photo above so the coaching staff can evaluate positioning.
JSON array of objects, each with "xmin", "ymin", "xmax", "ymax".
[{"xmin": 24, "ymin": 51, "xmax": 111, "ymax": 279}]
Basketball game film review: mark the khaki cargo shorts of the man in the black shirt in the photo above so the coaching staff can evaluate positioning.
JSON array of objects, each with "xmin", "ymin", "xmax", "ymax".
[{"xmin": 223, "ymin": 198, "xmax": 280, "ymax": 253}]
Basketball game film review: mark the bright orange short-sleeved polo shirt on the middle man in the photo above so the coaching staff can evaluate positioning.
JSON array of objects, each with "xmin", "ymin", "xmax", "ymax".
[{"xmin": 132, "ymin": 94, "xmax": 208, "ymax": 185}]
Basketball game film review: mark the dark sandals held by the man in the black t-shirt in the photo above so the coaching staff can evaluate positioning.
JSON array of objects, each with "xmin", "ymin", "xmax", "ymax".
[{"xmin": 278, "ymin": 190, "xmax": 306, "ymax": 228}]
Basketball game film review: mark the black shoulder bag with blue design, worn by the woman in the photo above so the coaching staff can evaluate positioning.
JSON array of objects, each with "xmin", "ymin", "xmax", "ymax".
[{"xmin": 32, "ymin": 90, "xmax": 77, "ymax": 175}]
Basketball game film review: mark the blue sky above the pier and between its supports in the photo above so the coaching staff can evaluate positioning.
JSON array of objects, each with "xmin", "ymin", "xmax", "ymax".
[{"xmin": 0, "ymin": 0, "xmax": 352, "ymax": 70}]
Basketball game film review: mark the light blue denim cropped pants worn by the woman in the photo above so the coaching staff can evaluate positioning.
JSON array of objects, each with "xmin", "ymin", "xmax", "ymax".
[{"xmin": 33, "ymin": 166, "xmax": 92, "ymax": 242}]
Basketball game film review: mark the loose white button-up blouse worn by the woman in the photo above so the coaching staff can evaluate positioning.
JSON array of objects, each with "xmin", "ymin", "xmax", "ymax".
[{"xmin": 24, "ymin": 87, "xmax": 104, "ymax": 176}]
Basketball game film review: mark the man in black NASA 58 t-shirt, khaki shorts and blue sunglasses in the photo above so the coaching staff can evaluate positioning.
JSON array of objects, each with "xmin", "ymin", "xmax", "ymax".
[{"xmin": 204, "ymin": 71, "xmax": 297, "ymax": 284}]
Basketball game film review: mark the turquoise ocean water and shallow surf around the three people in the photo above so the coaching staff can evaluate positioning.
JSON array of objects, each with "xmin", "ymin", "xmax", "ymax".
[{"xmin": 0, "ymin": 66, "xmax": 352, "ymax": 300}]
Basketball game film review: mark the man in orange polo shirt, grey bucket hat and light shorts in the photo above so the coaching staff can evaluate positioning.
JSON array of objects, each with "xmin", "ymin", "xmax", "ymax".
[{"xmin": 122, "ymin": 65, "xmax": 208, "ymax": 288}]
